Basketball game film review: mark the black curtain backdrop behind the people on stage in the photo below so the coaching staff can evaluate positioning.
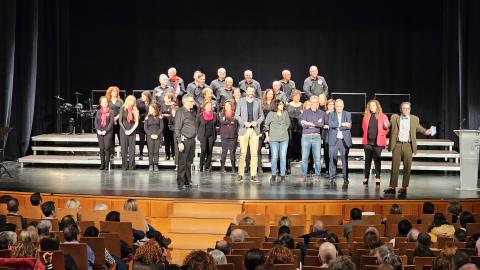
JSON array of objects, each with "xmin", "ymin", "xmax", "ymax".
[{"xmin": 0, "ymin": 0, "xmax": 480, "ymax": 159}]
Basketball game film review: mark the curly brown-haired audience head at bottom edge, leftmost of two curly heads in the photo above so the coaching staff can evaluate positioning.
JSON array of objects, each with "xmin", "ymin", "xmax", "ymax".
[{"xmin": 133, "ymin": 239, "xmax": 165, "ymax": 270}]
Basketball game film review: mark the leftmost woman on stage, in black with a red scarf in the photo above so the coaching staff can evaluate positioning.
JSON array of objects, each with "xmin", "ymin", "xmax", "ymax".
[{"xmin": 94, "ymin": 96, "xmax": 115, "ymax": 170}]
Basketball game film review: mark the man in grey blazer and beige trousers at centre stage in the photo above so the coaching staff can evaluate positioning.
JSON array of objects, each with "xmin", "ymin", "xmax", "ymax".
[{"xmin": 235, "ymin": 86, "xmax": 264, "ymax": 182}]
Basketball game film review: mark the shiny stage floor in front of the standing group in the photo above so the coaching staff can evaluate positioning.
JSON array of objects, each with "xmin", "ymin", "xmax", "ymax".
[{"xmin": 0, "ymin": 160, "xmax": 480, "ymax": 200}]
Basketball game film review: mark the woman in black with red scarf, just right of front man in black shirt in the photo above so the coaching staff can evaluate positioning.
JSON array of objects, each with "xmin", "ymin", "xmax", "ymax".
[{"xmin": 197, "ymin": 101, "xmax": 219, "ymax": 172}]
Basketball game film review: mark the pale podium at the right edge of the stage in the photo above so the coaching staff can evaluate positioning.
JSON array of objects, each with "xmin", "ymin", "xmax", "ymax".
[{"xmin": 454, "ymin": 129, "xmax": 480, "ymax": 190}]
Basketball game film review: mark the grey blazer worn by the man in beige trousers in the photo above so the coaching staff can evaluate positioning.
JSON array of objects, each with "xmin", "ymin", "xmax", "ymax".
[{"xmin": 235, "ymin": 97, "xmax": 265, "ymax": 136}]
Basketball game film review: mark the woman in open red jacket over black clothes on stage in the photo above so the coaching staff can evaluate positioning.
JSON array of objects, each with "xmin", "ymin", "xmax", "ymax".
[{"xmin": 362, "ymin": 99, "xmax": 390, "ymax": 185}]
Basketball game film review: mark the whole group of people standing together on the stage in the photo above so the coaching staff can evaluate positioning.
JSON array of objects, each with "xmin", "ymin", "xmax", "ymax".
[{"xmin": 95, "ymin": 66, "xmax": 436, "ymax": 194}]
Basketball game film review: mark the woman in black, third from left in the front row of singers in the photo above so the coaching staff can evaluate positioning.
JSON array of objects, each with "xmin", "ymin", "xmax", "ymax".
[{"xmin": 143, "ymin": 103, "xmax": 163, "ymax": 171}]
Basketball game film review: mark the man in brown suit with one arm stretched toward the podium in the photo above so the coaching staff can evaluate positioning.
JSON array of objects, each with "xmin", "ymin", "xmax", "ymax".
[{"xmin": 384, "ymin": 102, "xmax": 432, "ymax": 196}]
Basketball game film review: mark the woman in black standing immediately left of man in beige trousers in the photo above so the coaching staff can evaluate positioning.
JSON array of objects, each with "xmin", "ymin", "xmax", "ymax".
[{"xmin": 220, "ymin": 100, "xmax": 238, "ymax": 173}]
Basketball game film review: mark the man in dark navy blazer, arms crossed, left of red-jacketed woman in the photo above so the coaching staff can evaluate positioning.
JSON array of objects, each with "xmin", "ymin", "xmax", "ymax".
[{"xmin": 327, "ymin": 99, "xmax": 352, "ymax": 184}]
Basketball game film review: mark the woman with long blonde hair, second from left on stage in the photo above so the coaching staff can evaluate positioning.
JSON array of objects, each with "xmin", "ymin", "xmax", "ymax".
[{"xmin": 118, "ymin": 95, "xmax": 140, "ymax": 171}]
